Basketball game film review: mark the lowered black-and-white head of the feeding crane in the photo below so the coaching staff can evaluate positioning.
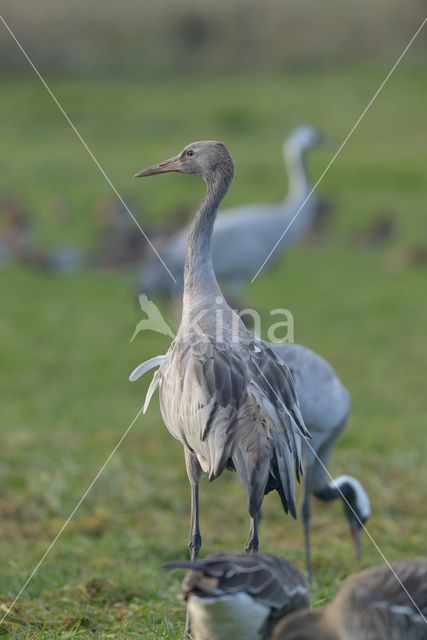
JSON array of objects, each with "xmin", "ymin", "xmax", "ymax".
[{"xmin": 333, "ymin": 476, "xmax": 371, "ymax": 562}]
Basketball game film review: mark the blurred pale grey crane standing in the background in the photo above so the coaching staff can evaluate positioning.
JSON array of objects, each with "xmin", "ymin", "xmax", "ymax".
[{"xmin": 139, "ymin": 125, "xmax": 321, "ymax": 295}]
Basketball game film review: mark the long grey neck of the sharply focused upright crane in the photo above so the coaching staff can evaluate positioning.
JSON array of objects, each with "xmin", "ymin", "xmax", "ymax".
[{"xmin": 183, "ymin": 165, "xmax": 233, "ymax": 308}]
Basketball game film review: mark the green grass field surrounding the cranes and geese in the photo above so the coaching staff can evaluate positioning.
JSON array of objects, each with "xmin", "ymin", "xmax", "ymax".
[{"xmin": 0, "ymin": 65, "xmax": 427, "ymax": 640}]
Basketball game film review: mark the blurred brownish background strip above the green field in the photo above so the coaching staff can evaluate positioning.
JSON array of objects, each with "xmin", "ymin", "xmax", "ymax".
[{"xmin": 0, "ymin": 0, "xmax": 426, "ymax": 75}]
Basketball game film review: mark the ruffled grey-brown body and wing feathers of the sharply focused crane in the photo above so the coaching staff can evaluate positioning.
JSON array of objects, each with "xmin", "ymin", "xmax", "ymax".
[{"xmin": 160, "ymin": 339, "xmax": 309, "ymax": 515}]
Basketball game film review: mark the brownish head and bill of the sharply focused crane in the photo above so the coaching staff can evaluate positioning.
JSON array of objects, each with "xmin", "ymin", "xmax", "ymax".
[{"xmin": 135, "ymin": 140, "xmax": 234, "ymax": 183}]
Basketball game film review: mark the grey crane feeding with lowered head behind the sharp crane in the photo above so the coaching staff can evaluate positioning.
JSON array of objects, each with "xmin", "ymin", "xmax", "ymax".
[{"xmin": 272, "ymin": 343, "xmax": 371, "ymax": 578}]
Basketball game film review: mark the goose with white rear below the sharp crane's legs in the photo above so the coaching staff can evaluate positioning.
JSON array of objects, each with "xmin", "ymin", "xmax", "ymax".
[{"xmin": 165, "ymin": 553, "xmax": 310, "ymax": 640}]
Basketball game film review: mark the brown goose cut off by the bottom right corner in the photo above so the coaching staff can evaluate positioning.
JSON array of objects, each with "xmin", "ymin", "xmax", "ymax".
[{"xmin": 272, "ymin": 559, "xmax": 427, "ymax": 640}]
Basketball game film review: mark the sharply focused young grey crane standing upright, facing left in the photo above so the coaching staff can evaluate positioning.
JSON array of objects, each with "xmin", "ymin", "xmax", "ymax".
[{"xmin": 134, "ymin": 141, "xmax": 309, "ymax": 559}]
